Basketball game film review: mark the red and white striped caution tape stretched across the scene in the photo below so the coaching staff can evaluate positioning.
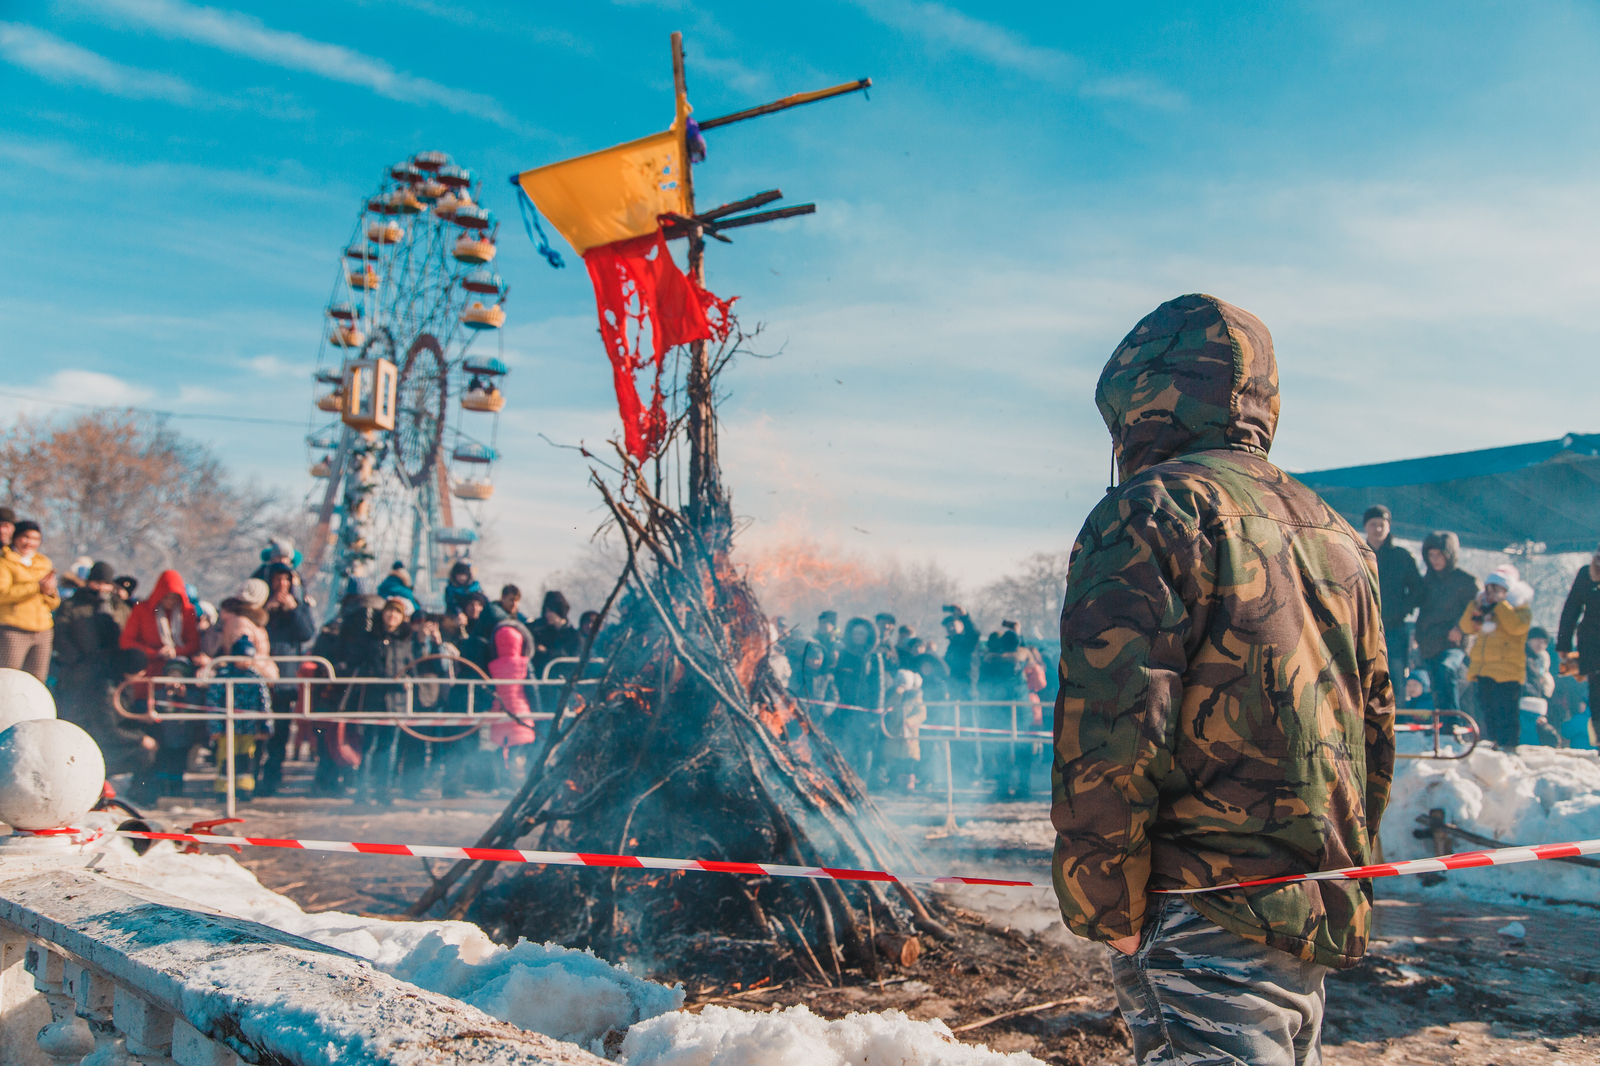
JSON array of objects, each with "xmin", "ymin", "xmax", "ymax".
[{"xmin": 84, "ymin": 829, "xmax": 1600, "ymax": 895}]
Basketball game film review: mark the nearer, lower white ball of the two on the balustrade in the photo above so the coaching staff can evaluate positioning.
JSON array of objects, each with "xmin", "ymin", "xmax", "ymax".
[{"xmin": 0, "ymin": 719, "xmax": 106, "ymax": 829}]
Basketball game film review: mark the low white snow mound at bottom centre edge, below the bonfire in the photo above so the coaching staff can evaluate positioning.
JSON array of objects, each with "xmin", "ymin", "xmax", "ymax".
[{"xmin": 621, "ymin": 1005, "xmax": 1040, "ymax": 1066}]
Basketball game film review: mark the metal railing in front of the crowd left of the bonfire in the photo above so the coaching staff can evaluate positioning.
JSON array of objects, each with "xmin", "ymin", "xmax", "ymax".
[{"xmin": 112, "ymin": 655, "xmax": 605, "ymax": 818}]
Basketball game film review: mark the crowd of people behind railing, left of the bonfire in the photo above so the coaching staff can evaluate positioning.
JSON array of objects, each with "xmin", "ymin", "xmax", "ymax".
[{"xmin": 0, "ymin": 507, "xmax": 598, "ymax": 804}]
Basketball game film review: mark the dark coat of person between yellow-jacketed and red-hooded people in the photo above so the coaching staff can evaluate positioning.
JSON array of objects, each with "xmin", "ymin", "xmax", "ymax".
[{"xmin": 54, "ymin": 589, "xmax": 149, "ymax": 776}]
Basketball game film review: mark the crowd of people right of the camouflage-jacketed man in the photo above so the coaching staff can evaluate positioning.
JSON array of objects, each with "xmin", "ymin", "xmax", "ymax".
[{"xmin": 1362, "ymin": 504, "xmax": 1600, "ymax": 751}]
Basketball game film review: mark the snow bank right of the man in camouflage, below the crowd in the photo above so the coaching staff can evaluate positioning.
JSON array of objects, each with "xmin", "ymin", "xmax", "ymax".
[{"xmin": 1378, "ymin": 746, "xmax": 1600, "ymax": 903}]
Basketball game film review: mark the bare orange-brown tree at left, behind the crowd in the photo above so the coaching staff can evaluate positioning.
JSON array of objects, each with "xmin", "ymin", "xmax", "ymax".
[{"xmin": 0, "ymin": 411, "xmax": 294, "ymax": 594}]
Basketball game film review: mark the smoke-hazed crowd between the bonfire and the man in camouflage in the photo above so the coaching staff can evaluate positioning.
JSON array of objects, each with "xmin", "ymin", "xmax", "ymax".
[{"xmin": 776, "ymin": 605, "xmax": 1051, "ymax": 799}]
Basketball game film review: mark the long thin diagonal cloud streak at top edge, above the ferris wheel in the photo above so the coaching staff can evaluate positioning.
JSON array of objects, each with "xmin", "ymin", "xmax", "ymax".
[{"xmin": 94, "ymin": 0, "xmax": 520, "ymax": 128}]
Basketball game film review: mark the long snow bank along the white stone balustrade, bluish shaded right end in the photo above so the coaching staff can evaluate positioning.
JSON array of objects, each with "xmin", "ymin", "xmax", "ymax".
[{"xmin": 123, "ymin": 844, "xmax": 683, "ymax": 1052}]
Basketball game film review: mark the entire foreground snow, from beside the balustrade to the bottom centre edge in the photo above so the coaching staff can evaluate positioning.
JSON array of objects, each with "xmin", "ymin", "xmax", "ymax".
[{"xmin": 109, "ymin": 840, "xmax": 1043, "ymax": 1066}]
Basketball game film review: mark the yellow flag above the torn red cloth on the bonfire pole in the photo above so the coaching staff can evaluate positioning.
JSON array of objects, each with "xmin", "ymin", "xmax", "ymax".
[{"xmin": 517, "ymin": 123, "xmax": 690, "ymax": 254}]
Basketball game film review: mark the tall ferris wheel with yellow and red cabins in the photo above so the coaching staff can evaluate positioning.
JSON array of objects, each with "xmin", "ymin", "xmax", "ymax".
[{"xmin": 306, "ymin": 152, "xmax": 507, "ymax": 605}]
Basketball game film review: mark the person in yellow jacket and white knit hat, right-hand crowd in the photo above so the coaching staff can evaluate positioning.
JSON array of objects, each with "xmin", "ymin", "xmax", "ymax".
[{"xmin": 1459, "ymin": 563, "xmax": 1533, "ymax": 751}]
